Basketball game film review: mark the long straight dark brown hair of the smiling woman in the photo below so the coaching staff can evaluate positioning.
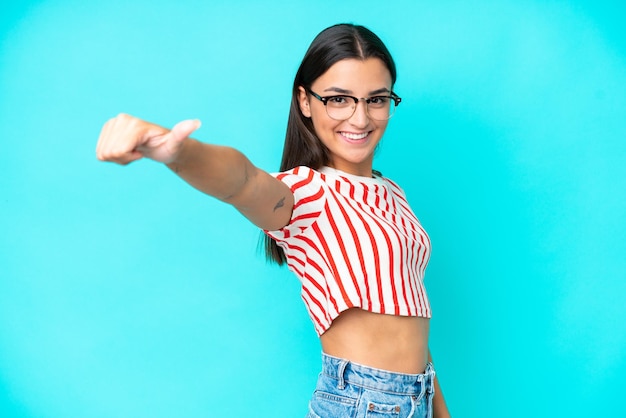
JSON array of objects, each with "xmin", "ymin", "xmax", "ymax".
[{"xmin": 264, "ymin": 23, "xmax": 396, "ymax": 265}]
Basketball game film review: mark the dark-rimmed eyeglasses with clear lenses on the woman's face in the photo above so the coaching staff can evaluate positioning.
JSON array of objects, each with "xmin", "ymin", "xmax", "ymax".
[{"xmin": 306, "ymin": 89, "xmax": 402, "ymax": 120}]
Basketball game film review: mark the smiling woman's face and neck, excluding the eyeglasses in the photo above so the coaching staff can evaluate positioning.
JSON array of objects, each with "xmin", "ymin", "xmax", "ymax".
[{"xmin": 298, "ymin": 58, "xmax": 392, "ymax": 177}]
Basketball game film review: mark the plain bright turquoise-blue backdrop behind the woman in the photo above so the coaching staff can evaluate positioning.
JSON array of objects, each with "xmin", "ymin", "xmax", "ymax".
[{"xmin": 0, "ymin": 0, "xmax": 626, "ymax": 418}]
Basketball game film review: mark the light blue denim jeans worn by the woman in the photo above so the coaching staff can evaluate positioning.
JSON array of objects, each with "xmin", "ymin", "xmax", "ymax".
[{"xmin": 307, "ymin": 353, "xmax": 435, "ymax": 418}]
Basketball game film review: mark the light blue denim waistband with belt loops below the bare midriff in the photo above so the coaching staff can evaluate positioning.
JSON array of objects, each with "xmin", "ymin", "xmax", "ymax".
[{"xmin": 322, "ymin": 353, "xmax": 435, "ymax": 395}]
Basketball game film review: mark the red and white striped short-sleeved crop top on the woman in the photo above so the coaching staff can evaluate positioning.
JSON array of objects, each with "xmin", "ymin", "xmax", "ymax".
[{"xmin": 265, "ymin": 167, "xmax": 431, "ymax": 335}]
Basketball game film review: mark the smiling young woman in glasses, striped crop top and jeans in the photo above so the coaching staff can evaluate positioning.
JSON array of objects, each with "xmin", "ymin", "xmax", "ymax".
[{"xmin": 97, "ymin": 24, "xmax": 449, "ymax": 418}]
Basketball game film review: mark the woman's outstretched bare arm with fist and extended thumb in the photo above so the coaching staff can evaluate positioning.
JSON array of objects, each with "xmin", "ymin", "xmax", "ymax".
[{"xmin": 96, "ymin": 114, "xmax": 293, "ymax": 230}]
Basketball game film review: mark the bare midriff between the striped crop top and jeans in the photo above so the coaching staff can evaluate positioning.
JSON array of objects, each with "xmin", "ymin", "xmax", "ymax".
[{"xmin": 320, "ymin": 308, "xmax": 429, "ymax": 374}]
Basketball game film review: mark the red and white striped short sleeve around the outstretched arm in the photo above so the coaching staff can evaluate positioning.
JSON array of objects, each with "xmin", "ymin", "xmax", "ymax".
[{"xmin": 264, "ymin": 167, "xmax": 326, "ymax": 242}]
